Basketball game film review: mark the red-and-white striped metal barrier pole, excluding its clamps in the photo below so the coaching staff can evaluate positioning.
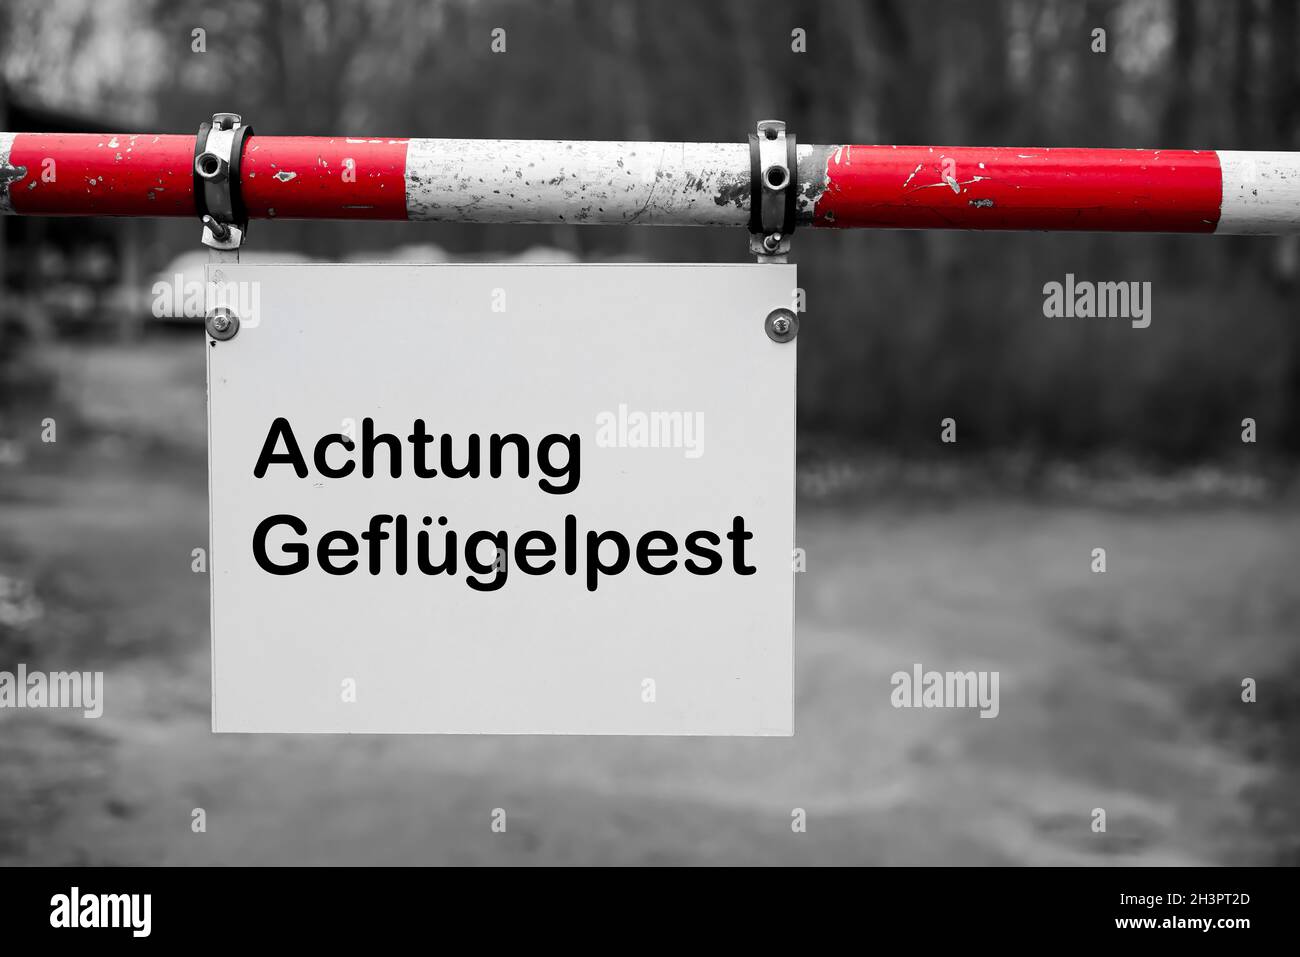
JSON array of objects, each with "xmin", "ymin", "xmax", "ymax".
[{"xmin": 0, "ymin": 133, "xmax": 1300, "ymax": 234}]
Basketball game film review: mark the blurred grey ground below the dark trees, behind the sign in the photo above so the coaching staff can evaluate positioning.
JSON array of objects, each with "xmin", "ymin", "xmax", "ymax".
[{"xmin": 0, "ymin": 330, "xmax": 1300, "ymax": 865}]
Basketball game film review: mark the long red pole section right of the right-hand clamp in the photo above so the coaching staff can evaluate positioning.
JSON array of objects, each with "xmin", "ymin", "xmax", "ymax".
[{"xmin": 813, "ymin": 146, "xmax": 1223, "ymax": 233}]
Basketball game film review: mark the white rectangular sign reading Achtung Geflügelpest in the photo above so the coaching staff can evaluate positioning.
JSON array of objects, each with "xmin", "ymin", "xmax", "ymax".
[{"xmin": 207, "ymin": 264, "xmax": 797, "ymax": 735}]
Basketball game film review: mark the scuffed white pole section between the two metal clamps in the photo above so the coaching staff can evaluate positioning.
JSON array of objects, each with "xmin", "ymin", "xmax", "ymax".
[{"xmin": 406, "ymin": 139, "xmax": 750, "ymax": 226}]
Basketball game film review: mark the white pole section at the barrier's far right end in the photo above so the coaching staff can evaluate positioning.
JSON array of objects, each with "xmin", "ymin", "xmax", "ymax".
[{"xmin": 1214, "ymin": 150, "xmax": 1300, "ymax": 235}]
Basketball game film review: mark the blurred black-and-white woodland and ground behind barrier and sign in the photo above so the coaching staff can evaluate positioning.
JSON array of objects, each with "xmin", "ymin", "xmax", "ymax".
[{"xmin": 0, "ymin": 0, "xmax": 1300, "ymax": 863}]
